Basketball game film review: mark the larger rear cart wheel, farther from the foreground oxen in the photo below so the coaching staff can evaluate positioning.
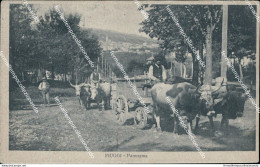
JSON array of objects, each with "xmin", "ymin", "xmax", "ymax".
[{"xmin": 114, "ymin": 95, "xmax": 128, "ymax": 125}]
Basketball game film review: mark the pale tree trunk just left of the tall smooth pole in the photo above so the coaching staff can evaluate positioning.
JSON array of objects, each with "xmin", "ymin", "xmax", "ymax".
[{"xmin": 205, "ymin": 25, "xmax": 212, "ymax": 85}]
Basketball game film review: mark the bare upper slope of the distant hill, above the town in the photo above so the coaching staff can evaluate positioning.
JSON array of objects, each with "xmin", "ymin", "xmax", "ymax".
[{"xmin": 88, "ymin": 29, "xmax": 157, "ymax": 45}]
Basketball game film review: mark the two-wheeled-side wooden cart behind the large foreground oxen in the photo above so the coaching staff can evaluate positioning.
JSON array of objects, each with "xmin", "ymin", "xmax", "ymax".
[{"xmin": 112, "ymin": 79, "xmax": 152, "ymax": 129}]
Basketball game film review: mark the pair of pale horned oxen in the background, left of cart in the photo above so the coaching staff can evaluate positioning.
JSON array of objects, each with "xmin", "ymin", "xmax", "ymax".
[{"xmin": 69, "ymin": 82, "xmax": 111, "ymax": 110}]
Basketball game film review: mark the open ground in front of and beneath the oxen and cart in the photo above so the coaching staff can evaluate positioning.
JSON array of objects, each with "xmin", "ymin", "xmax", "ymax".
[{"xmin": 9, "ymin": 84, "xmax": 256, "ymax": 152}]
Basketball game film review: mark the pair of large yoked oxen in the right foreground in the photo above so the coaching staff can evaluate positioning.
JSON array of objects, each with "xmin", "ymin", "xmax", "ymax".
[{"xmin": 151, "ymin": 77, "xmax": 246, "ymax": 135}]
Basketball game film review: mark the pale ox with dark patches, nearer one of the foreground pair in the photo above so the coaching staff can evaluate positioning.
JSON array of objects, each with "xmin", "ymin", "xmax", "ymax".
[{"xmin": 151, "ymin": 82, "xmax": 221, "ymax": 133}]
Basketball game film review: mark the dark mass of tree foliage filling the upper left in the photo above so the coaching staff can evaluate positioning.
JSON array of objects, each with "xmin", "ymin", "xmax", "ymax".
[{"xmin": 10, "ymin": 5, "xmax": 101, "ymax": 83}]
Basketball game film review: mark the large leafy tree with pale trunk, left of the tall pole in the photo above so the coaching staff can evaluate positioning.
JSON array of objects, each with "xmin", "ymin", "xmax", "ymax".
[{"xmin": 140, "ymin": 5, "xmax": 221, "ymax": 83}]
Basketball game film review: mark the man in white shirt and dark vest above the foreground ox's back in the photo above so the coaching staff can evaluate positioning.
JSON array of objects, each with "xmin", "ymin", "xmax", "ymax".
[{"xmin": 148, "ymin": 56, "xmax": 167, "ymax": 85}]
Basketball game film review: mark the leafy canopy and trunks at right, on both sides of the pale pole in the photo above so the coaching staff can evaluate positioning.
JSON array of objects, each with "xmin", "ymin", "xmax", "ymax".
[{"xmin": 140, "ymin": 5, "xmax": 256, "ymax": 83}]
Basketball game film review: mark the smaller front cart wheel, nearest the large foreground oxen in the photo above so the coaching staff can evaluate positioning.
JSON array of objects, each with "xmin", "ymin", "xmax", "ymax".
[{"xmin": 134, "ymin": 107, "xmax": 147, "ymax": 129}]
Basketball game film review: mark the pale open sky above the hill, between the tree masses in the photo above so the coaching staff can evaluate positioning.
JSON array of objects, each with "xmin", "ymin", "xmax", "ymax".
[{"xmin": 34, "ymin": 1, "xmax": 149, "ymax": 38}]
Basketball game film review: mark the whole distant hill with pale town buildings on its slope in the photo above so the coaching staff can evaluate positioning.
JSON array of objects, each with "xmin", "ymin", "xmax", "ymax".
[{"xmin": 87, "ymin": 29, "xmax": 159, "ymax": 77}]
